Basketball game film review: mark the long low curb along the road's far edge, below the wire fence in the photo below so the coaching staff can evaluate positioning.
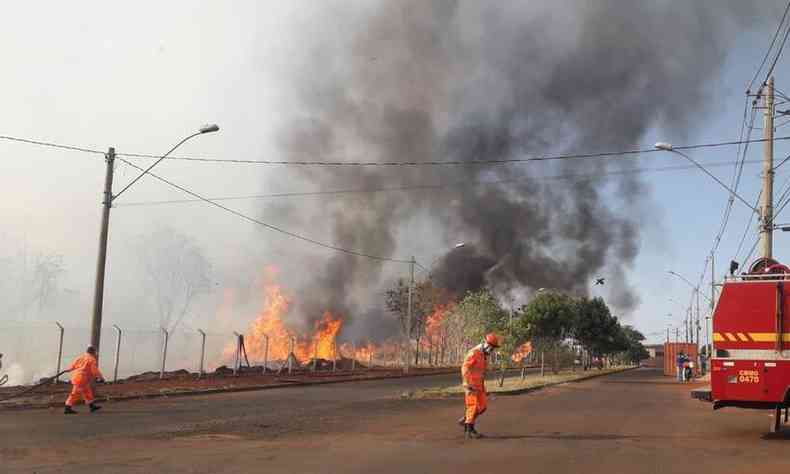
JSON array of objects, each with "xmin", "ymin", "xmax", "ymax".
[{"xmin": 0, "ymin": 369, "xmax": 458, "ymax": 412}]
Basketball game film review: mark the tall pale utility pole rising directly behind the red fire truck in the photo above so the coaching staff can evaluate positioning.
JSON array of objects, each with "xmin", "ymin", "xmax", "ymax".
[{"xmin": 760, "ymin": 77, "xmax": 774, "ymax": 258}]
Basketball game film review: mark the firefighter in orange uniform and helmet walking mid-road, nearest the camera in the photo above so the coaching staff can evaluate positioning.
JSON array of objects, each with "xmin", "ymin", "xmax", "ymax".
[{"xmin": 458, "ymin": 334, "xmax": 499, "ymax": 439}]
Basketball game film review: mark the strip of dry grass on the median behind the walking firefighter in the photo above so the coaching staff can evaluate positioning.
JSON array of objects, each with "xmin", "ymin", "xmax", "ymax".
[{"xmin": 403, "ymin": 367, "xmax": 623, "ymax": 399}]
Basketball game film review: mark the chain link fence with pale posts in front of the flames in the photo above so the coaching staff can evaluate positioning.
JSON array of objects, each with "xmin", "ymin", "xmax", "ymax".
[{"xmin": 0, "ymin": 321, "xmax": 457, "ymax": 385}]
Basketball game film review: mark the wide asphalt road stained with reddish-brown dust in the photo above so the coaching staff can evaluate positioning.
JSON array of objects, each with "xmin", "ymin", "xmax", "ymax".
[{"xmin": 0, "ymin": 370, "xmax": 790, "ymax": 474}]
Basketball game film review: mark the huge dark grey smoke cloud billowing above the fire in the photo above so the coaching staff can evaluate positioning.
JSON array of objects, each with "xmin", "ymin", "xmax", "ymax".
[{"xmin": 268, "ymin": 0, "xmax": 773, "ymax": 330}]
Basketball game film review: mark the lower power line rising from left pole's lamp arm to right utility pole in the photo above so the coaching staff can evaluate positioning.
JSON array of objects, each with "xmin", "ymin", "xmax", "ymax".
[{"xmin": 114, "ymin": 160, "xmax": 762, "ymax": 207}]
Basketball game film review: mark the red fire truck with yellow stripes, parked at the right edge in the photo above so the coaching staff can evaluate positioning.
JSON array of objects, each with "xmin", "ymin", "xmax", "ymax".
[{"xmin": 693, "ymin": 258, "xmax": 790, "ymax": 432}]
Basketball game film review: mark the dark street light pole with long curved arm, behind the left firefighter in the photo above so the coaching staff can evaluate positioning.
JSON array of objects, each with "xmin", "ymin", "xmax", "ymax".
[{"xmin": 91, "ymin": 124, "xmax": 219, "ymax": 357}]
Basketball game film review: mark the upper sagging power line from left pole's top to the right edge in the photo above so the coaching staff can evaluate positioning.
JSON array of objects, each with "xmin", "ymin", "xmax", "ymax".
[{"xmin": 116, "ymin": 136, "xmax": 790, "ymax": 166}]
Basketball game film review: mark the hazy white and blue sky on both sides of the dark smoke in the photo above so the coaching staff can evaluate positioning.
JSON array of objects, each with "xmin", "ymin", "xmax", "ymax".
[{"xmin": 0, "ymin": 1, "xmax": 790, "ymax": 372}]
